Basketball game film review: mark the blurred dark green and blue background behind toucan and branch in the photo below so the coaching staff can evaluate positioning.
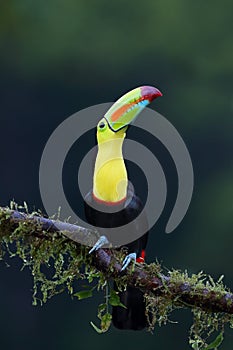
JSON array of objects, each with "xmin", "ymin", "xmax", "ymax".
[{"xmin": 0, "ymin": 0, "xmax": 233, "ymax": 350}]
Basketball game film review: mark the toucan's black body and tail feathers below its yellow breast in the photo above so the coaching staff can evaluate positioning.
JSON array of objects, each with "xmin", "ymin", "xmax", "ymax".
[{"xmin": 85, "ymin": 189, "xmax": 148, "ymax": 330}]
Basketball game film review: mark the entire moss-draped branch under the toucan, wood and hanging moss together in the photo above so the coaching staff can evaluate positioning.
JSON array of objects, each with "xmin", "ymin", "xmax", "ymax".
[{"xmin": 0, "ymin": 205, "xmax": 233, "ymax": 349}]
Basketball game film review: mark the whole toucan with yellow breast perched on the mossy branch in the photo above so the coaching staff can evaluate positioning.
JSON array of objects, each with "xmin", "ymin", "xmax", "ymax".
[{"xmin": 84, "ymin": 86, "xmax": 162, "ymax": 330}]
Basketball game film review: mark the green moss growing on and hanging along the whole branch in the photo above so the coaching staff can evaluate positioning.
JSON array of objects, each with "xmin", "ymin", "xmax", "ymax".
[{"xmin": 0, "ymin": 203, "xmax": 233, "ymax": 350}]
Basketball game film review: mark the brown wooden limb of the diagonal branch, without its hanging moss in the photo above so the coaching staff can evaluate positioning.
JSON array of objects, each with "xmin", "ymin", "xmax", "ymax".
[{"xmin": 0, "ymin": 208, "xmax": 233, "ymax": 314}]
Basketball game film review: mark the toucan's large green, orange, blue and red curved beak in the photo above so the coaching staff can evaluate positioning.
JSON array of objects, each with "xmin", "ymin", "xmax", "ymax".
[{"xmin": 104, "ymin": 86, "xmax": 162, "ymax": 131}]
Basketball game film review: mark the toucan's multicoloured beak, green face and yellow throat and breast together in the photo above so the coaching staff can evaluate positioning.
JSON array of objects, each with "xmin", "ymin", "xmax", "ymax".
[{"xmin": 93, "ymin": 86, "xmax": 162, "ymax": 203}]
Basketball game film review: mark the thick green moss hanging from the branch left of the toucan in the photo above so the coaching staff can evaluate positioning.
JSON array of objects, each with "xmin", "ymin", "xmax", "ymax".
[{"xmin": 0, "ymin": 208, "xmax": 105, "ymax": 305}]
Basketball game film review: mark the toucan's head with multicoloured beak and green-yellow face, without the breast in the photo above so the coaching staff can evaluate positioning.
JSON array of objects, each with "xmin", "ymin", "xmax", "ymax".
[{"xmin": 97, "ymin": 86, "xmax": 162, "ymax": 144}]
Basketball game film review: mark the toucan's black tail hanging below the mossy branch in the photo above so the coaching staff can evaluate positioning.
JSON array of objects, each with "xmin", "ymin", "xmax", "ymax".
[{"xmin": 112, "ymin": 287, "xmax": 147, "ymax": 330}]
